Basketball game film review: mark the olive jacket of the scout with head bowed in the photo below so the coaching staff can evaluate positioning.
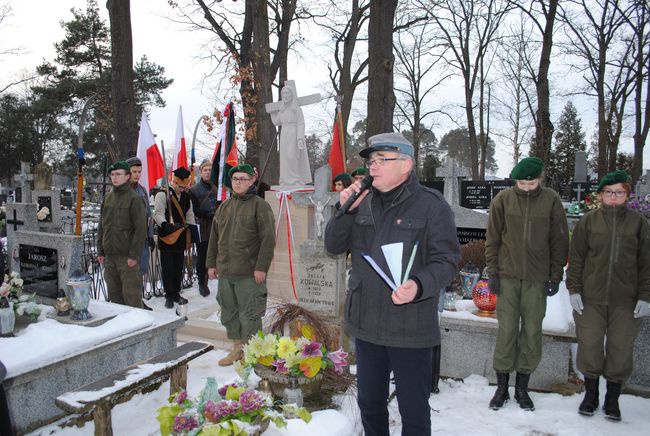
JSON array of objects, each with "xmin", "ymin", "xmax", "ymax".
[{"xmin": 485, "ymin": 186, "xmax": 569, "ymax": 283}]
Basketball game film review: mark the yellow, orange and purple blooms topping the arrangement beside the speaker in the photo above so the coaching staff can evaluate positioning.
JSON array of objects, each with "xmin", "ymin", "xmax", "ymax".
[{"xmin": 243, "ymin": 329, "xmax": 348, "ymax": 378}]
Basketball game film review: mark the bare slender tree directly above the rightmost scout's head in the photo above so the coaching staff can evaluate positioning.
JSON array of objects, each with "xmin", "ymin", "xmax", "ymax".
[{"xmin": 562, "ymin": 0, "xmax": 628, "ymax": 178}]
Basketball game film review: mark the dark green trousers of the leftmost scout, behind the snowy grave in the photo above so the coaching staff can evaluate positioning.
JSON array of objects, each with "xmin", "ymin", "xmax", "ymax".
[{"xmin": 104, "ymin": 255, "xmax": 143, "ymax": 309}]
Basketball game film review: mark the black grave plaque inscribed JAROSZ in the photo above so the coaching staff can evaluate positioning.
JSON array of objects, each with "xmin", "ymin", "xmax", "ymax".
[{"xmin": 18, "ymin": 244, "xmax": 59, "ymax": 298}]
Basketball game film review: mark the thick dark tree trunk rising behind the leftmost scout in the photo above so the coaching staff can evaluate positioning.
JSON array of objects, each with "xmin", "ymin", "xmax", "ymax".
[{"xmin": 106, "ymin": 0, "xmax": 138, "ymax": 159}]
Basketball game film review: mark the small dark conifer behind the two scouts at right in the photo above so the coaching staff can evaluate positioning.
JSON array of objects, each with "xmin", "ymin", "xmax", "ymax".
[{"xmin": 546, "ymin": 101, "xmax": 587, "ymax": 184}]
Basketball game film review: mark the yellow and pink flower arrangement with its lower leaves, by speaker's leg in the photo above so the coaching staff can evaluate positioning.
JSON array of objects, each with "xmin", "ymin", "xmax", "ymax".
[{"xmin": 236, "ymin": 326, "xmax": 348, "ymax": 397}]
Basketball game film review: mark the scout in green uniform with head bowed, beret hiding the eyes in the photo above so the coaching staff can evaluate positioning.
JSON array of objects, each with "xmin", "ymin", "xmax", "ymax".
[{"xmin": 485, "ymin": 157, "xmax": 569, "ymax": 410}]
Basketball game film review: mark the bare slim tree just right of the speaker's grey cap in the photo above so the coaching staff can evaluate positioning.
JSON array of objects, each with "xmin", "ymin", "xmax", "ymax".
[{"xmin": 394, "ymin": 21, "xmax": 451, "ymax": 168}]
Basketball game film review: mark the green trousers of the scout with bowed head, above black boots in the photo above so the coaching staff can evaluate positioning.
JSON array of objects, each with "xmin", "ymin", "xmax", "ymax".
[{"xmin": 492, "ymin": 277, "xmax": 546, "ymax": 374}]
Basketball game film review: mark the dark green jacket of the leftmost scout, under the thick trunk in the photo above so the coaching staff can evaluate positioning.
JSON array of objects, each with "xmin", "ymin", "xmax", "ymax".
[{"xmin": 97, "ymin": 183, "xmax": 147, "ymax": 259}]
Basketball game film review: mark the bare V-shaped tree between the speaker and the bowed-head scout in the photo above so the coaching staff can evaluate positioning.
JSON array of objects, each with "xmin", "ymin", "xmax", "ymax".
[{"xmin": 422, "ymin": 0, "xmax": 511, "ymax": 180}]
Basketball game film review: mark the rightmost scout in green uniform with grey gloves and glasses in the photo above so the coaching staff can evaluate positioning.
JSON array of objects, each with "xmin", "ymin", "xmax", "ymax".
[{"xmin": 567, "ymin": 170, "xmax": 650, "ymax": 421}]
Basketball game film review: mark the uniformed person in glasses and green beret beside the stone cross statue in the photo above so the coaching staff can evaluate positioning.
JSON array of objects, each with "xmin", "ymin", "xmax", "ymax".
[{"xmin": 206, "ymin": 164, "xmax": 275, "ymax": 366}]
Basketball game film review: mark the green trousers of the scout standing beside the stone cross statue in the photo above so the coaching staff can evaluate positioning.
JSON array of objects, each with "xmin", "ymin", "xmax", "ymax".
[{"xmin": 217, "ymin": 277, "xmax": 267, "ymax": 342}]
